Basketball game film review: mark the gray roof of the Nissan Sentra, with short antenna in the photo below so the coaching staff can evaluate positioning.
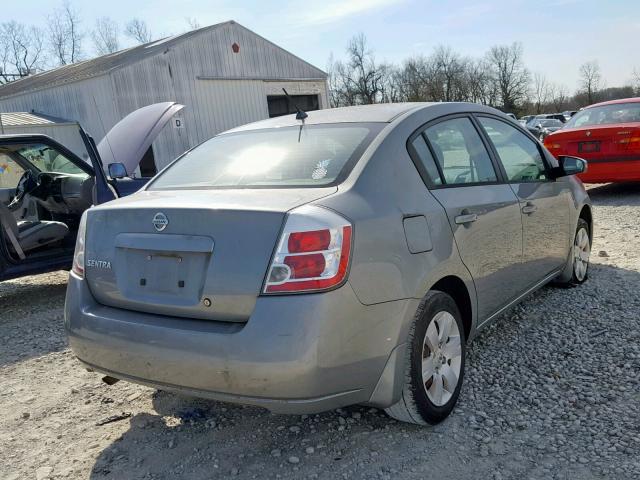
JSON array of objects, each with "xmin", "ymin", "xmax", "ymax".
[{"xmin": 225, "ymin": 102, "xmax": 438, "ymax": 133}]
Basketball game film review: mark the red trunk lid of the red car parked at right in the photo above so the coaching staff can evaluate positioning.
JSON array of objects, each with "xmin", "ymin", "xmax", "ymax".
[{"xmin": 545, "ymin": 123, "xmax": 640, "ymax": 159}]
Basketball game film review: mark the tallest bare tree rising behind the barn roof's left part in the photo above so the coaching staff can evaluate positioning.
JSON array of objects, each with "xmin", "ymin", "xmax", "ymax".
[{"xmin": 47, "ymin": 1, "xmax": 84, "ymax": 65}]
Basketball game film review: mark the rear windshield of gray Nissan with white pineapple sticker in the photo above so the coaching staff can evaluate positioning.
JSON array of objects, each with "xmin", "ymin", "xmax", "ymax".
[{"xmin": 148, "ymin": 123, "xmax": 384, "ymax": 190}]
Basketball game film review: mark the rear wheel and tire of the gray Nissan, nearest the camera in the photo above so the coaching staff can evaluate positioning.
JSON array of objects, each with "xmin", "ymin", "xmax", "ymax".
[{"xmin": 385, "ymin": 290, "xmax": 466, "ymax": 425}]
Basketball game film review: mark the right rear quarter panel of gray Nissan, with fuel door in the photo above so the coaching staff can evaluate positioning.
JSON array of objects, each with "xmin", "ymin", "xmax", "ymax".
[{"xmin": 316, "ymin": 106, "xmax": 476, "ymax": 336}]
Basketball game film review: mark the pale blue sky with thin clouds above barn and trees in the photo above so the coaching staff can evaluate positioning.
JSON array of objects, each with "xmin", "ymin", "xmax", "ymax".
[{"xmin": 5, "ymin": 0, "xmax": 640, "ymax": 92}]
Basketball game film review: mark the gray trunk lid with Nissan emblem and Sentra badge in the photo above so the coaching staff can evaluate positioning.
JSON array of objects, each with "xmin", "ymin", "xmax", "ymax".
[{"xmin": 85, "ymin": 187, "xmax": 337, "ymax": 322}]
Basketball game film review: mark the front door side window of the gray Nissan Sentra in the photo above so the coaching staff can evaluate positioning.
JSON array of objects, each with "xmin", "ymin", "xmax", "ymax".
[{"xmin": 479, "ymin": 117, "xmax": 547, "ymax": 183}]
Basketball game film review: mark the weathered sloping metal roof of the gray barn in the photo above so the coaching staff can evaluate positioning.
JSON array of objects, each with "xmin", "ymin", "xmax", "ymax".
[{"xmin": 0, "ymin": 20, "xmax": 326, "ymax": 99}]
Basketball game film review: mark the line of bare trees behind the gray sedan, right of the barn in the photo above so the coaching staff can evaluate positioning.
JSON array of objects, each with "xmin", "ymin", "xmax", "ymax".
[{"xmin": 327, "ymin": 34, "xmax": 640, "ymax": 115}]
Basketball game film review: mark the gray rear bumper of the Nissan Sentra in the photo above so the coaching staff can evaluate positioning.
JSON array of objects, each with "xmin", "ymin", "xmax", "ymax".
[{"xmin": 65, "ymin": 274, "xmax": 417, "ymax": 413}]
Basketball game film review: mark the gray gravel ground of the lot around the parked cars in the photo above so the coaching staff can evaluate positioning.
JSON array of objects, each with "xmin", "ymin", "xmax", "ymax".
[{"xmin": 0, "ymin": 182, "xmax": 640, "ymax": 480}]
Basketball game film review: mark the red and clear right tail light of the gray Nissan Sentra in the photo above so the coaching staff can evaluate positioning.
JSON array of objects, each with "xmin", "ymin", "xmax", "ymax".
[{"xmin": 263, "ymin": 205, "xmax": 352, "ymax": 293}]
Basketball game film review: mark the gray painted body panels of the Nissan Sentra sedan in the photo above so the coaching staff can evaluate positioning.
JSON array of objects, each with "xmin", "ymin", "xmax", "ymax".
[{"xmin": 65, "ymin": 104, "xmax": 589, "ymax": 413}]
